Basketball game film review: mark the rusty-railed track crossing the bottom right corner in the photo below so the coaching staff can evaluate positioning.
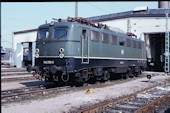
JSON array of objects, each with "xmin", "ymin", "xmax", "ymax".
[{"xmin": 78, "ymin": 85, "xmax": 170, "ymax": 113}]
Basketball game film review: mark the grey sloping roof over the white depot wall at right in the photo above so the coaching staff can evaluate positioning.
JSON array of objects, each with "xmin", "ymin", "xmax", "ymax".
[{"xmin": 86, "ymin": 8, "xmax": 170, "ymax": 22}]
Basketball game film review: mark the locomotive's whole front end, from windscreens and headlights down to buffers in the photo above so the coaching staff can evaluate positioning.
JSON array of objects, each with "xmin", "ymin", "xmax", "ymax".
[{"xmin": 35, "ymin": 22, "xmax": 73, "ymax": 82}]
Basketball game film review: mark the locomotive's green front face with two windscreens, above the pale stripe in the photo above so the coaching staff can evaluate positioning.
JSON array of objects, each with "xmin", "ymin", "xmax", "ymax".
[{"xmin": 36, "ymin": 22, "xmax": 69, "ymax": 56}]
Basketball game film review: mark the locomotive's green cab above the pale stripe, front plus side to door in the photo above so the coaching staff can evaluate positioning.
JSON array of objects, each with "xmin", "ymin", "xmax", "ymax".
[{"xmin": 36, "ymin": 22, "xmax": 87, "ymax": 57}]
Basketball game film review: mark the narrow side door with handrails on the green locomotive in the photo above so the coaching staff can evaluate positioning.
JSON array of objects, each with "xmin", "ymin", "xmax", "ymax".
[{"xmin": 81, "ymin": 28, "xmax": 90, "ymax": 64}]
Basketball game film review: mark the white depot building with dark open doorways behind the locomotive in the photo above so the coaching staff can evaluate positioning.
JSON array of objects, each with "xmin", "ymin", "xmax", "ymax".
[{"xmin": 13, "ymin": 3, "xmax": 170, "ymax": 72}]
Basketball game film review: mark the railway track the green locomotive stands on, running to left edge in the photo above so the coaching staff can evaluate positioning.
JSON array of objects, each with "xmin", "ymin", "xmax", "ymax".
[{"xmin": 1, "ymin": 73, "xmax": 147, "ymax": 104}]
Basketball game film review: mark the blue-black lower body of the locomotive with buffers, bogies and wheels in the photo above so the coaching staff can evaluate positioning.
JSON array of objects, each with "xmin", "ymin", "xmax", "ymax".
[{"xmin": 34, "ymin": 58, "xmax": 146, "ymax": 84}]
